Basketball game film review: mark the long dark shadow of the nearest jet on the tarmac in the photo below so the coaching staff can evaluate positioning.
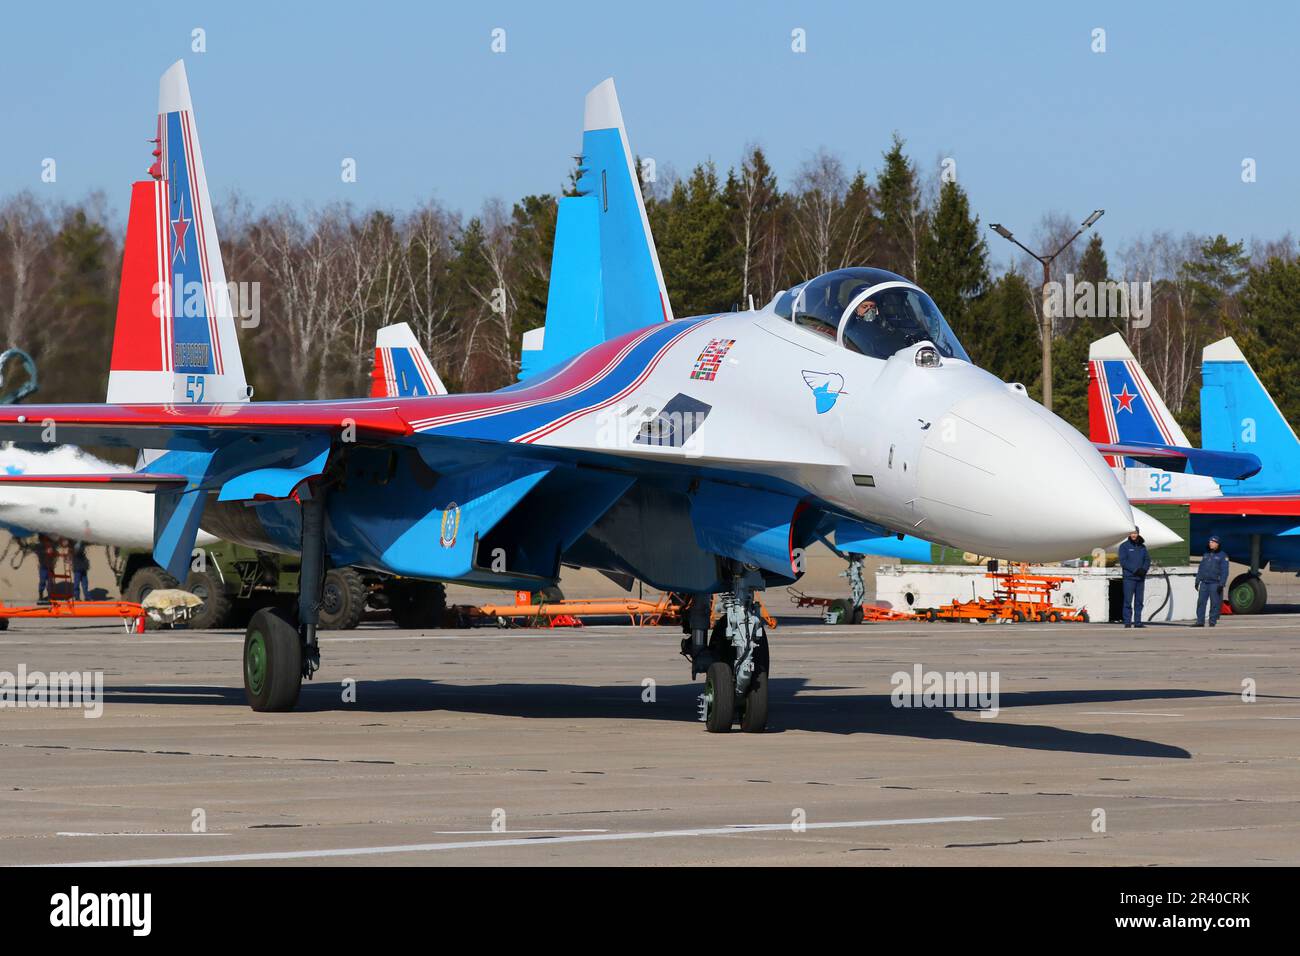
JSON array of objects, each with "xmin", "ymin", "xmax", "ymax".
[{"xmin": 83, "ymin": 678, "xmax": 1279, "ymax": 760}]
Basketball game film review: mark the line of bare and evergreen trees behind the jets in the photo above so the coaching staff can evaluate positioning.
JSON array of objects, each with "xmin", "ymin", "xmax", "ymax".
[{"xmin": 0, "ymin": 135, "xmax": 1300, "ymax": 434}]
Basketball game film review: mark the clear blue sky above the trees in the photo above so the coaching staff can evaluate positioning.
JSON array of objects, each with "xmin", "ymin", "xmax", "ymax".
[{"xmin": 0, "ymin": 0, "xmax": 1300, "ymax": 261}]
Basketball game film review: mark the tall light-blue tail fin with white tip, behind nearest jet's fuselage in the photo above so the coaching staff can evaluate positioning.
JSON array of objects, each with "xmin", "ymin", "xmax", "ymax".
[{"xmin": 520, "ymin": 79, "xmax": 672, "ymax": 378}]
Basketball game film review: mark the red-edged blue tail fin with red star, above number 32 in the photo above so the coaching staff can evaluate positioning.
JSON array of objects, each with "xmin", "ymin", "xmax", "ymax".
[{"xmin": 1088, "ymin": 332, "xmax": 1188, "ymax": 447}]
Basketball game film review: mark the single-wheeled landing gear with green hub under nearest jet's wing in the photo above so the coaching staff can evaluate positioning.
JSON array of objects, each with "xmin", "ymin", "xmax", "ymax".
[{"xmin": 243, "ymin": 488, "xmax": 325, "ymax": 710}]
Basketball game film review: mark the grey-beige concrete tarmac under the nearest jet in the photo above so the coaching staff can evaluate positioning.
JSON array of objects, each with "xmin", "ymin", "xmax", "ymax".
[{"xmin": 0, "ymin": 606, "xmax": 1300, "ymax": 866}]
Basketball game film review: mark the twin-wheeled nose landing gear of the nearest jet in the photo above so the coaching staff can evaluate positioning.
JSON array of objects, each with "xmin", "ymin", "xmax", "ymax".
[{"xmin": 681, "ymin": 571, "xmax": 771, "ymax": 734}]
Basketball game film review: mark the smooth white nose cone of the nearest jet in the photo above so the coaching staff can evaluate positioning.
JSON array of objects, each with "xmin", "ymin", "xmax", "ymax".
[{"xmin": 918, "ymin": 388, "xmax": 1134, "ymax": 561}]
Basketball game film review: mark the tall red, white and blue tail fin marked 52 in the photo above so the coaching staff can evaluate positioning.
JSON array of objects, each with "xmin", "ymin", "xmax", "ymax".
[{"xmin": 108, "ymin": 61, "xmax": 248, "ymax": 403}]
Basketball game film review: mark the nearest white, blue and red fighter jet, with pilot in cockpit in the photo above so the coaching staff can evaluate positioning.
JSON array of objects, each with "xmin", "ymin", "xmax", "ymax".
[{"xmin": 0, "ymin": 64, "xmax": 1134, "ymax": 732}]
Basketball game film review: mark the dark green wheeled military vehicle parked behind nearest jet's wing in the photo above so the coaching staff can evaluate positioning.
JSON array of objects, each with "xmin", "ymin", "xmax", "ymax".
[{"xmin": 112, "ymin": 541, "xmax": 447, "ymax": 631}]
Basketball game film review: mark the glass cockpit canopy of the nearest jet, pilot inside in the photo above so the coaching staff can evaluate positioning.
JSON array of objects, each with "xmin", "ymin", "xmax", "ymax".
[{"xmin": 772, "ymin": 268, "xmax": 970, "ymax": 362}]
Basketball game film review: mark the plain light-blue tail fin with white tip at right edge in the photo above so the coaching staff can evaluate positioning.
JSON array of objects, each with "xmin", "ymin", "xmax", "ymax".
[{"xmin": 1201, "ymin": 338, "xmax": 1300, "ymax": 494}]
